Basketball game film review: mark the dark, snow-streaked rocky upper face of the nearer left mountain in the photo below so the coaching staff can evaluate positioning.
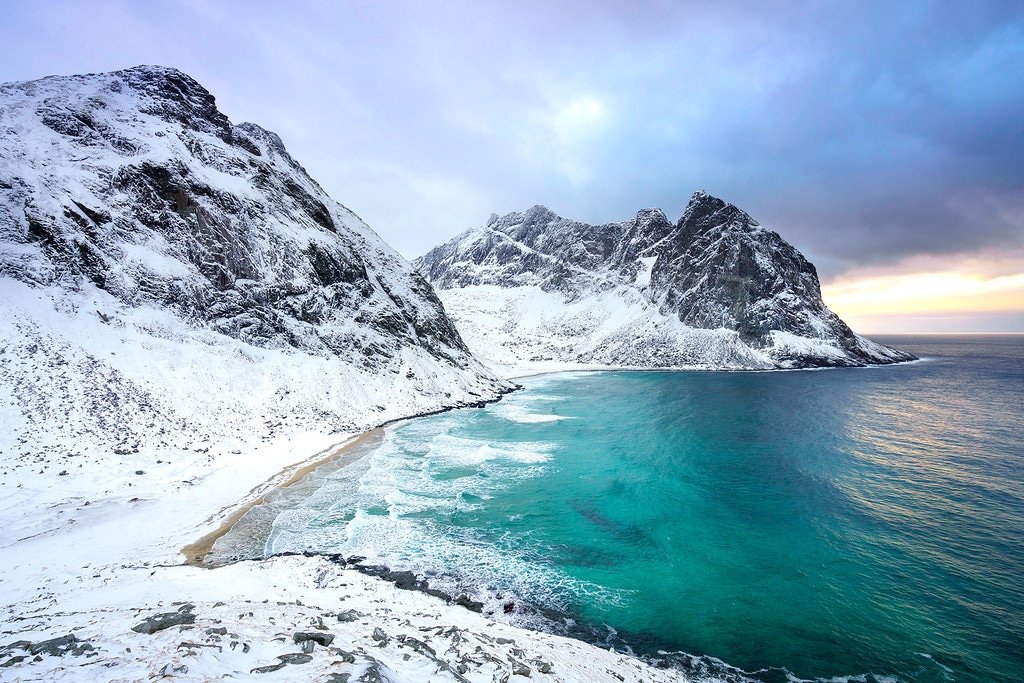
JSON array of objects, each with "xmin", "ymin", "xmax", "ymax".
[{"xmin": 0, "ymin": 67, "xmax": 477, "ymax": 367}]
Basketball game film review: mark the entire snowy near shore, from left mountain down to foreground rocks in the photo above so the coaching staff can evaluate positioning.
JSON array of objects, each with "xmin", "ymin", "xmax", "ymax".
[{"xmin": 0, "ymin": 68, "xmax": 696, "ymax": 681}]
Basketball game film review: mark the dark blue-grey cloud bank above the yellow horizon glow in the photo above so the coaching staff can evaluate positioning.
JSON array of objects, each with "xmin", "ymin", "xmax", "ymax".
[{"xmin": 565, "ymin": 3, "xmax": 1024, "ymax": 272}]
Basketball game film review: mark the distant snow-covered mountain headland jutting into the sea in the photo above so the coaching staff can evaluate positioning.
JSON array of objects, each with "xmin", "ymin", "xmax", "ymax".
[{"xmin": 415, "ymin": 191, "xmax": 913, "ymax": 370}]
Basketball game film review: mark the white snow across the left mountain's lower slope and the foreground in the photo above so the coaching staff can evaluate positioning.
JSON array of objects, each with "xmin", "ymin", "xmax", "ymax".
[{"xmin": 0, "ymin": 279, "xmax": 696, "ymax": 682}]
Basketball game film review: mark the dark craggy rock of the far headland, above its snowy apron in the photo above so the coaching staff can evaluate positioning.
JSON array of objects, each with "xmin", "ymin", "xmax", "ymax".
[{"xmin": 416, "ymin": 191, "xmax": 912, "ymax": 368}]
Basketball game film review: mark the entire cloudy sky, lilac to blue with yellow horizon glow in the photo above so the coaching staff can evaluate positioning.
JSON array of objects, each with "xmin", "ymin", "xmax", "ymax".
[{"xmin": 0, "ymin": 0, "xmax": 1024, "ymax": 333}]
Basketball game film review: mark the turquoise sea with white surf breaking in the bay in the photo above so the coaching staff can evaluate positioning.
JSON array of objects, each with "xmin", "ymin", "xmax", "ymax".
[{"xmin": 266, "ymin": 336, "xmax": 1024, "ymax": 682}]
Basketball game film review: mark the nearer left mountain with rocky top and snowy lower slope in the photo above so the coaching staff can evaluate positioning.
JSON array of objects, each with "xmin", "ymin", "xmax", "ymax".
[{"xmin": 0, "ymin": 67, "xmax": 509, "ymax": 501}]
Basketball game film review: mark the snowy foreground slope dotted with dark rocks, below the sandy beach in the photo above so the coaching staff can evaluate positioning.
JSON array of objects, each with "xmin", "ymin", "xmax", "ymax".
[{"xmin": 0, "ymin": 515, "xmax": 683, "ymax": 683}]
